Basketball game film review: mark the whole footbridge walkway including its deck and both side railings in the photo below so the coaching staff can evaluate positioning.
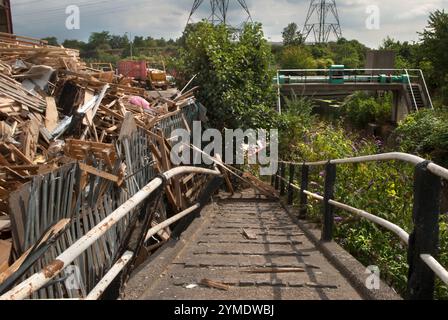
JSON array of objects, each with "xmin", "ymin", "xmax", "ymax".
[{"xmin": 0, "ymin": 153, "xmax": 448, "ymax": 300}]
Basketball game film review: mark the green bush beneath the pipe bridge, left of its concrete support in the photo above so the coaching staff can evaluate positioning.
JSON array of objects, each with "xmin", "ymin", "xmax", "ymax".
[{"xmin": 341, "ymin": 92, "xmax": 392, "ymax": 128}]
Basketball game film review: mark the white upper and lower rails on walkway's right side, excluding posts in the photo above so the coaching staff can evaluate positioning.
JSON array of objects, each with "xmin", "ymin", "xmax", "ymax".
[{"xmin": 275, "ymin": 152, "xmax": 448, "ymax": 285}]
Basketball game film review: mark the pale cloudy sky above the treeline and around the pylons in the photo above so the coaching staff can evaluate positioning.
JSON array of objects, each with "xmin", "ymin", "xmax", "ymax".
[{"xmin": 11, "ymin": 0, "xmax": 448, "ymax": 48}]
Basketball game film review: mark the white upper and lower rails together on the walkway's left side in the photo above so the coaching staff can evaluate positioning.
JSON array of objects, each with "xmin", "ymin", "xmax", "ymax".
[{"xmin": 0, "ymin": 167, "xmax": 221, "ymax": 300}]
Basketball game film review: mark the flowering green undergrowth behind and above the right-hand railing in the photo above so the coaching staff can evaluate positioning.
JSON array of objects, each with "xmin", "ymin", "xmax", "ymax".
[{"xmin": 280, "ymin": 98, "xmax": 448, "ymax": 299}]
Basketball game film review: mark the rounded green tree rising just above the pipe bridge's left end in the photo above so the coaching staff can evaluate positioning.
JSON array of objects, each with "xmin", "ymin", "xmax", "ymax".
[{"xmin": 279, "ymin": 46, "xmax": 317, "ymax": 69}]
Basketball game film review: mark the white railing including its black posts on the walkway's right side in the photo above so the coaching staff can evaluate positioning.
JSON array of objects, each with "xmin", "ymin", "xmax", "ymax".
[{"xmin": 272, "ymin": 152, "xmax": 448, "ymax": 299}]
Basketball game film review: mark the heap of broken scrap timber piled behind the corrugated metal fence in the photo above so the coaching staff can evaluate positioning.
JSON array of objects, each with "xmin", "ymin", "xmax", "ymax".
[{"xmin": 0, "ymin": 33, "xmax": 202, "ymax": 280}]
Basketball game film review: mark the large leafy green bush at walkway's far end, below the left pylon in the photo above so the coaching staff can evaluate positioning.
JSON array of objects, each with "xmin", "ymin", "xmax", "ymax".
[{"xmin": 177, "ymin": 22, "xmax": 275, "ymax": 129}]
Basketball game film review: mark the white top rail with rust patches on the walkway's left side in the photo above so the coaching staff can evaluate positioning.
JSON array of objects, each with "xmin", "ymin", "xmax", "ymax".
[{"xmin": 0, "ymin": 167, "xmax": 221, "ymax": 300}]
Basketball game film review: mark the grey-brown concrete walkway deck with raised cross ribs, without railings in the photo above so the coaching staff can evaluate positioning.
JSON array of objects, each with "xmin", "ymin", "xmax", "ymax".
[{"xmin": 125, "ymin": 192, "xmax": 400, "ymax": 300}]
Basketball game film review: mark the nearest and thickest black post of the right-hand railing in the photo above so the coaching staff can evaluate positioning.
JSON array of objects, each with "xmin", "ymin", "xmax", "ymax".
[{"xmin": 407, "ymin": 161, "xmax": 441, "ymax": 300}]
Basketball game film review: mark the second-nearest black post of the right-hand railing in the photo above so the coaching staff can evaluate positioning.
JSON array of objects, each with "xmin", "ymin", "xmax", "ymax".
[{"xmin": 322, "ymin": 163, "xmax": 336, "ymax": 242}]
